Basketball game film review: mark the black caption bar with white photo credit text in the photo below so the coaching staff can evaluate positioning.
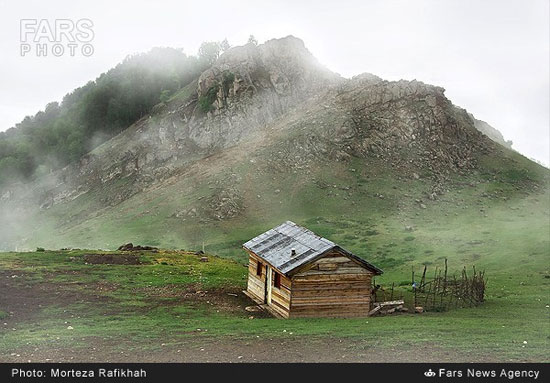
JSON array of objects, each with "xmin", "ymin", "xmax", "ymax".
[{"xmin": 0, "ymin": 363, "xmax": 550, "ymax": 382}]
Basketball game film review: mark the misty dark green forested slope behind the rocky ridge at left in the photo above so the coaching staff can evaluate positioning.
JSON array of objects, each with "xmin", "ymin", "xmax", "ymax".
[{"xmin": 0, "ymin": 36, "xmax": 255, "ymax": 185}]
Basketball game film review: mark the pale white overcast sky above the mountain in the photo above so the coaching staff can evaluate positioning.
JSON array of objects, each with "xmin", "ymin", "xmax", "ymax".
[{"xmin": 0, "ymin": 0, "xmax": 550, "ymax": 165}]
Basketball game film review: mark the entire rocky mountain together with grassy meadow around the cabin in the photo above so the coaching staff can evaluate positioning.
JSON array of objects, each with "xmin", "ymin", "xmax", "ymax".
[{"xmin": 0, "ymin": 36, "xmax": 550, "ymax": 362}]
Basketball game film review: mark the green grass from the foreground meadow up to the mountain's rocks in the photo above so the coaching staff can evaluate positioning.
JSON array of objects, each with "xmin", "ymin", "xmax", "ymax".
[{"xmin": 0, "ymin": 146, "xmax": 550, "ymax": 361}]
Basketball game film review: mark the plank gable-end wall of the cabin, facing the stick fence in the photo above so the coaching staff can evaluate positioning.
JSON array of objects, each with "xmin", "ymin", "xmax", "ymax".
[{"xmin": 290, "ymin": 251, "xmax": 373, "ymax": 317}]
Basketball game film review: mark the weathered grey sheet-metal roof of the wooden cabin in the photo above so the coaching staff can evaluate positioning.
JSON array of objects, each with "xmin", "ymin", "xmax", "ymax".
[{"xmin": 243, "ymin": 221, "xmax": 382, "ymax": 275}]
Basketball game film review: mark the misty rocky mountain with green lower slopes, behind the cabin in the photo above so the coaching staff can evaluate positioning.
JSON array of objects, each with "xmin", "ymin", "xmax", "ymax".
[{"xmin": 0, "ymin": 36, "xmax": 548, "ymax": 249}]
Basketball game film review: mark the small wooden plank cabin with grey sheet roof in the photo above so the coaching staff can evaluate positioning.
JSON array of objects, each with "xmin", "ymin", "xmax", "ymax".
[{"xmin": 243, "ymin": 221, "xmax": 382, "ymax": 318}]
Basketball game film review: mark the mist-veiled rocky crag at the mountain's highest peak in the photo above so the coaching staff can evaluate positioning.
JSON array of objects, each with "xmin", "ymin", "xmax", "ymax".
[{"xmin": 189, "ymin": 36, "xmax": 342, "ymax": 148}]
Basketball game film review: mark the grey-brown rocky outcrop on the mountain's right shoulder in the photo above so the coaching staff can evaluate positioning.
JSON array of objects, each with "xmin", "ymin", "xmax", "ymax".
[{"xmin": 330, "ymin": 76, "xmax": 494, "ymax": 174}]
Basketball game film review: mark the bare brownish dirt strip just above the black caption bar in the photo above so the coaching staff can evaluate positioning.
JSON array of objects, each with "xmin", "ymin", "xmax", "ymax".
[{"xmin": 0, "ymin": 337, "xmax": 497, "ymax": 363}]
